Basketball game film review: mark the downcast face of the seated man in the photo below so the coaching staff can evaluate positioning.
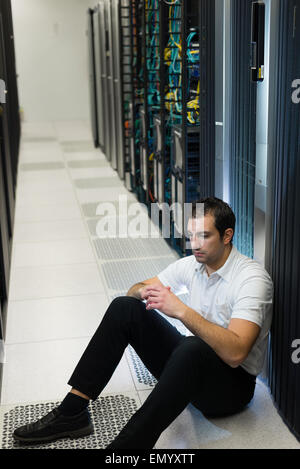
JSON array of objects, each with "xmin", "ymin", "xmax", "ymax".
[{"xmin": 187, "ymin": 214, "xmax": 228, "ymax": 265}]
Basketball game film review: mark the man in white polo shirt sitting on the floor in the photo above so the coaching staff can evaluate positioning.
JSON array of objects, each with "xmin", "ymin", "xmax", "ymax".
[{"xmin": 14, "ymin": 198, "xmax": 273, "ymax": 449}]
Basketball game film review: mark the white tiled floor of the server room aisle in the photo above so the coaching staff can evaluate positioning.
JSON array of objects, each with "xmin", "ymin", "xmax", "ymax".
[{"xmin": 0, "ymin": 122, "xmax": 300, "ymax": 448}]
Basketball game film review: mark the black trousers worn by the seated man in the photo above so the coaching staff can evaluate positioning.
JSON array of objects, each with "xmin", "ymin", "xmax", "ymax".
[{"xmin": 68, "ymin": 297, "xmax": 256, "ymax": 449}]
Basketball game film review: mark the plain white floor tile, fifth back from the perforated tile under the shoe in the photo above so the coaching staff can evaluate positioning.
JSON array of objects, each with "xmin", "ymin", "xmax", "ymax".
[{"xmin": 14, "ymin": 220, "xmax": 88, "ymax": 243}]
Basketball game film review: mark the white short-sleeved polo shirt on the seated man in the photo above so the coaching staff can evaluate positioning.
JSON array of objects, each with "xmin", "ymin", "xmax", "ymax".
[{"xmin": 158, "ymin": 246, "xmax": 273, "ymax": 376}]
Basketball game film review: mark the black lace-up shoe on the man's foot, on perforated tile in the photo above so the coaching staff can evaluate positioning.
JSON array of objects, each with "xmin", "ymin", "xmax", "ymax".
[{"xmin": 13, "ymin": 408, "xmax": 94, "ymax": 443}]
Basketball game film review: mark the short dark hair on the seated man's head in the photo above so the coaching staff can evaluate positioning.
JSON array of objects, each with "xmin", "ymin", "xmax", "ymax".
[{"xmin": 192, "ymin": 197, "xmax": 236, "ymax": 242}]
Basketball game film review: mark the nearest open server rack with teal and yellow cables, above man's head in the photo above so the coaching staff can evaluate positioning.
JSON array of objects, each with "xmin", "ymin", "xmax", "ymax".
[{"xmin": 166, "ymin": 0, "xmax": 215, "ymax": 254}]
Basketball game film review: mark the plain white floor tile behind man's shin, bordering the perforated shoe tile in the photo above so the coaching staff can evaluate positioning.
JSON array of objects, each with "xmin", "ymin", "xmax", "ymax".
[{"xmin": 1, "ymin": 337, "xmax": 135, "ymax": 405}]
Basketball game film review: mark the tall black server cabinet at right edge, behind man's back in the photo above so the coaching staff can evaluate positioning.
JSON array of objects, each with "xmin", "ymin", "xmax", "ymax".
[{"xmin": 269, "ymin": 0, "xmax": 300, "ymax": 440}]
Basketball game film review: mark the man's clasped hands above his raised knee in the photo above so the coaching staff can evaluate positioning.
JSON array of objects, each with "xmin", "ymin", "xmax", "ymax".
[{"xmin": 140, "ymin": 284, "xmax": 186, "ymax": 319}]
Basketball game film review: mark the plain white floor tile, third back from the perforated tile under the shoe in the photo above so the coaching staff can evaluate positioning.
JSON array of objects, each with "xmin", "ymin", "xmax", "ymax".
[{"xmin": 9, "ymin": 264, "xmax": 104, "ymax": 301}]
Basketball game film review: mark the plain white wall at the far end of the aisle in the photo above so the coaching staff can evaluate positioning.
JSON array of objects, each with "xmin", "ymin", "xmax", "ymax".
[{"xmin": 12, "ymin": 0, "xmax": 92, "ymax": 122}]
